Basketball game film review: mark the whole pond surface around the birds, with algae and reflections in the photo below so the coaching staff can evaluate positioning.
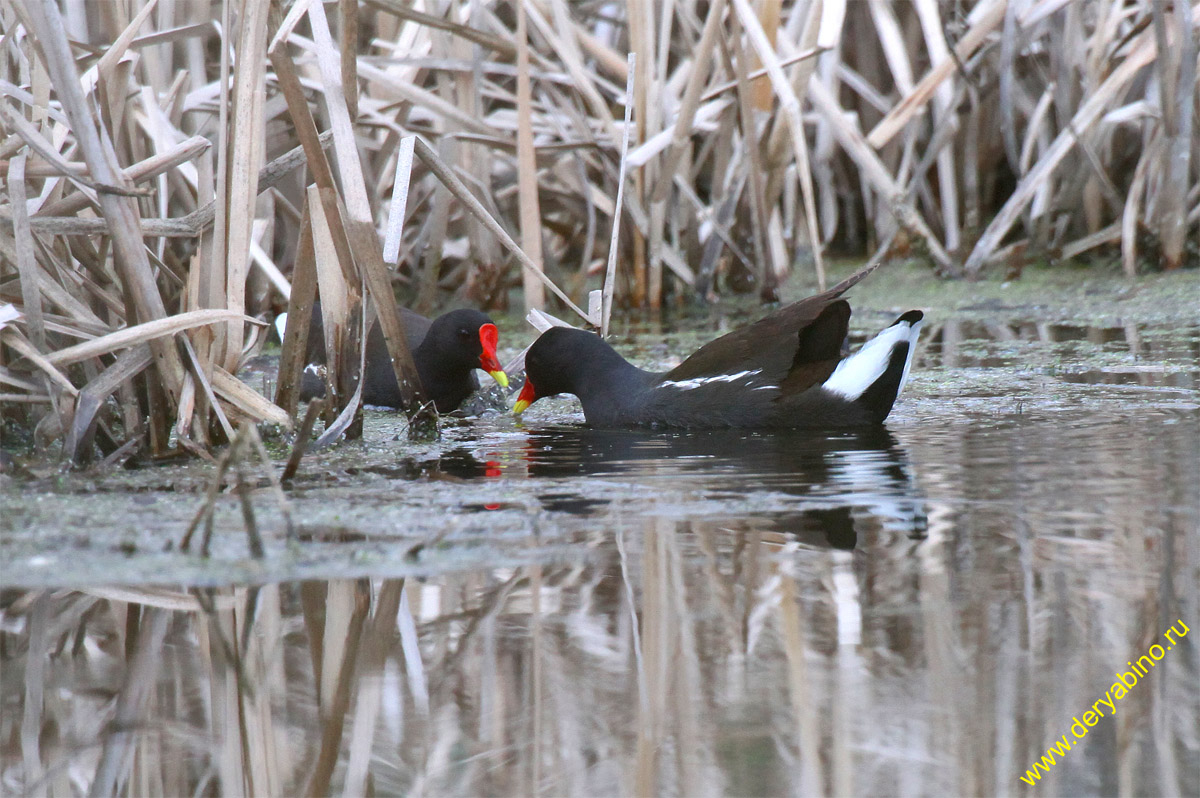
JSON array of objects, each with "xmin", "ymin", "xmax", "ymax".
[{"xmin": 0, "ymin": 318, "xmax": 1200, "ymax": 796}]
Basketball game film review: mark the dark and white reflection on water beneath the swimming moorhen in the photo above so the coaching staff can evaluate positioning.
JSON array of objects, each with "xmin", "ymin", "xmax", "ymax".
[{"xmin": 436, "ymin": 426, "xmax": 926, "ymax": 550}]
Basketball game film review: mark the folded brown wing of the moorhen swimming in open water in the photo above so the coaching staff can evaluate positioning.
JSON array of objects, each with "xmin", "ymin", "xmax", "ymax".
[{"xmin": 665, "ymin": 291, "xmax": 850, "ymax": 384}]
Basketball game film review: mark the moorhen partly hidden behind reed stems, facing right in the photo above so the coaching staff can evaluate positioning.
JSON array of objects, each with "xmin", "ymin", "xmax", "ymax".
[{"xmin": 276, "ymin": 302, "xmax": 509, "ymax": 413}]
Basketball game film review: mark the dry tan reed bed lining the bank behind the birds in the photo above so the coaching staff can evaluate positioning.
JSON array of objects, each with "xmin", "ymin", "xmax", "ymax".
[{"xmin": 0, "ymin": 0, "xmax": 1200, "ymax": 462}]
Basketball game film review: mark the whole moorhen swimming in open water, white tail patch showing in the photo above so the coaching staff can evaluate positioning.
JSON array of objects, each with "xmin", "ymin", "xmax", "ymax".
[{"xmin": 512, "ymin": 280, "xmax": 922, "ymax": 430}]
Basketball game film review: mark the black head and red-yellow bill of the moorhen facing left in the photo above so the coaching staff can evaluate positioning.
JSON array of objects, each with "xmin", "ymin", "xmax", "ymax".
[{"xmin": 512, "ymin": 326, "xmax": 624, "ymax": 413}]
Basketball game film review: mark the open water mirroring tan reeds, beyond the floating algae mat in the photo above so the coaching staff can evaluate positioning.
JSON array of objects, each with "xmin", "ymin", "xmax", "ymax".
[{"xmin": 0, "ymin": 413, "xmax": 1200, "ymax": 796}]
